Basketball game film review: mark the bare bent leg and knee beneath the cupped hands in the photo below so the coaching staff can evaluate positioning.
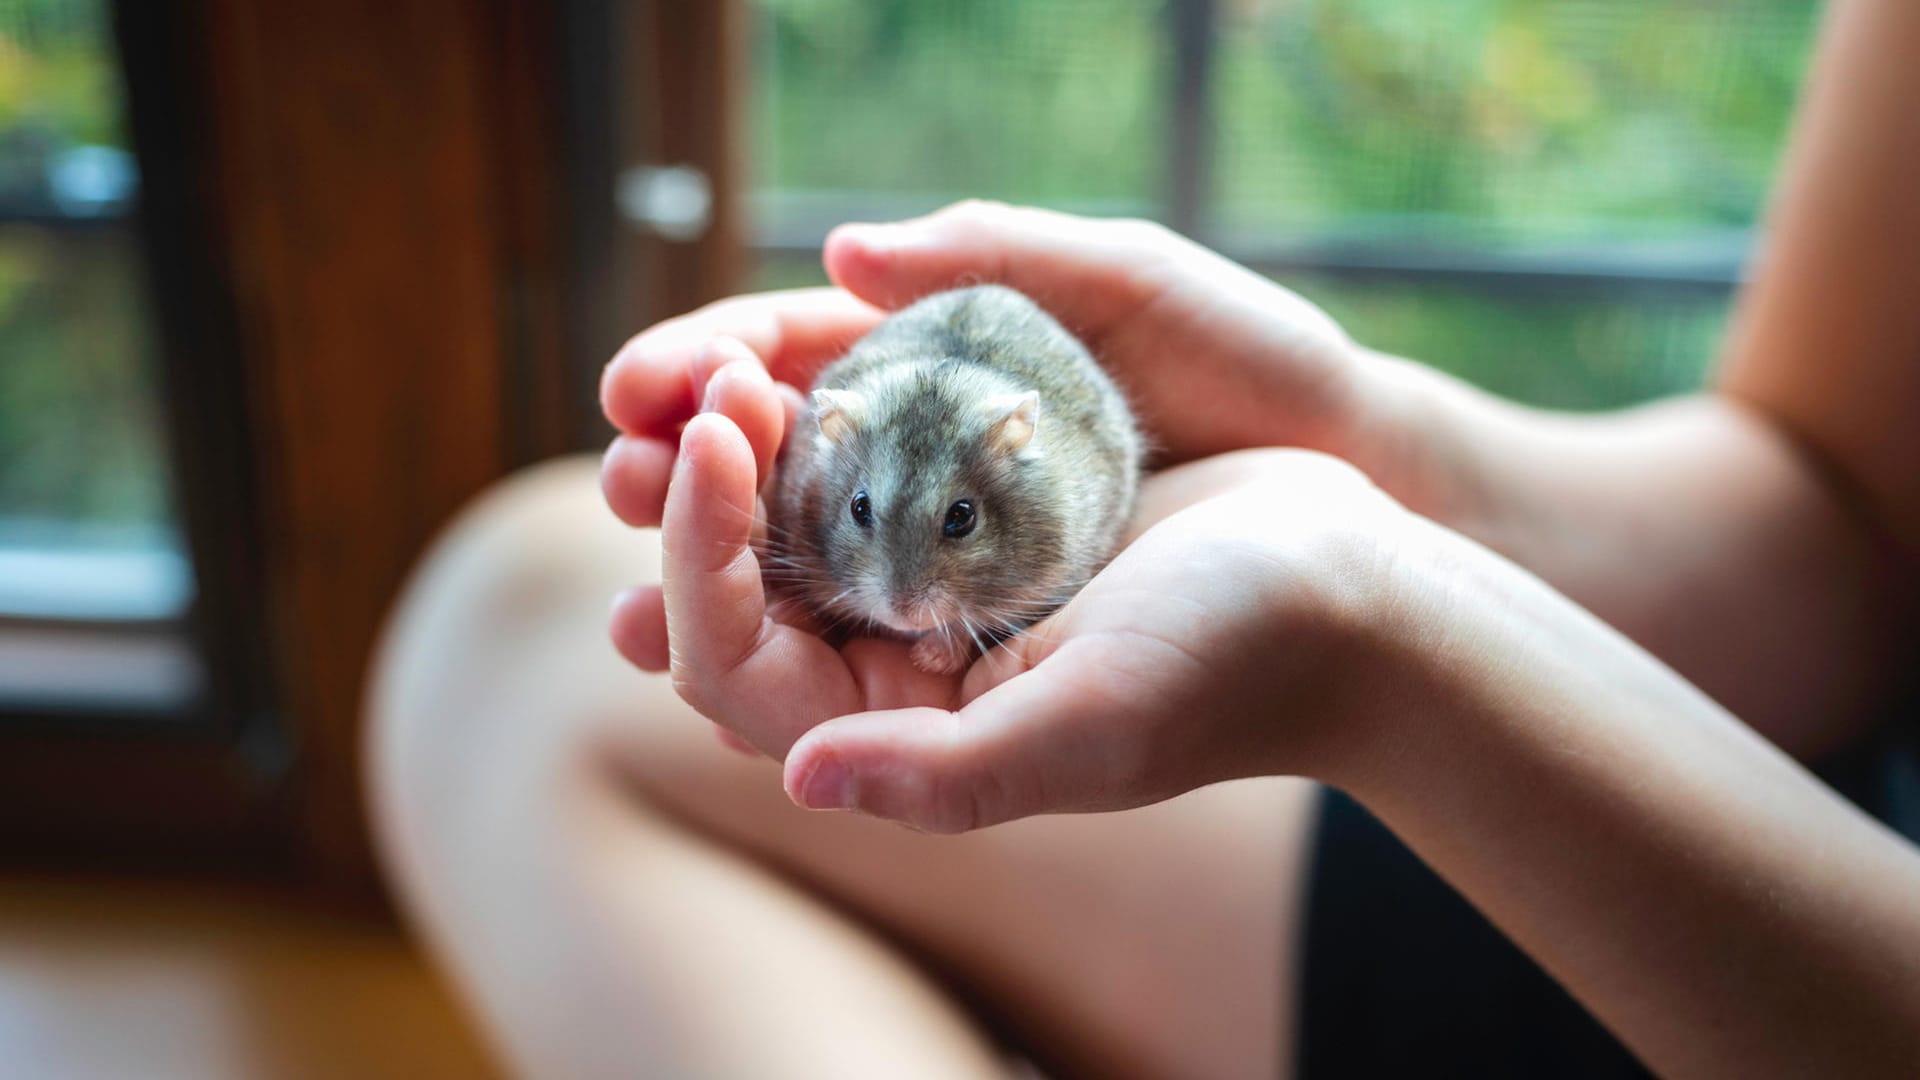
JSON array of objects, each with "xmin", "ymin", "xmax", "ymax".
[{"xmin": 369, "ymin": 461, "xmax": 1309, "ymax": 1076}]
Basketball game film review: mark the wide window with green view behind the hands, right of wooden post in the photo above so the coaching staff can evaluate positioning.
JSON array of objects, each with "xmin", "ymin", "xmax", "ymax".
[{"xmin": 729, "ymin": 0, "xmax": 1816, "ymax": 407}]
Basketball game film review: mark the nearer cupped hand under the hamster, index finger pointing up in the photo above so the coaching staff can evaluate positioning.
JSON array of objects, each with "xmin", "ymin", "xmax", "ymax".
[{"xmin": 614, "ymin": 403, "xmax": 1415, "ymax": 832}]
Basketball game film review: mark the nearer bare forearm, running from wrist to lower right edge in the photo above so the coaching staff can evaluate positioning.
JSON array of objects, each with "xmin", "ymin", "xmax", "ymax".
[{"xmin": 1334, "ymin": 526, "xmax": 1920, "ymax": 1076}]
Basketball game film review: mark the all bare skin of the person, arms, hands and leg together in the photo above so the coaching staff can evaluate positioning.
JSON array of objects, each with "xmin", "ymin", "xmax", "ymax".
[{"xmin": 374, "ymin": 0, "xmax": 1920, "ymax": 1076}]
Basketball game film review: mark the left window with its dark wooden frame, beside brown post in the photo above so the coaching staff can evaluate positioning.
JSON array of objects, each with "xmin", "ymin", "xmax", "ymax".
[{"xmin": 0, "ymin": 0, "xmax": 286, "ymax": 861}]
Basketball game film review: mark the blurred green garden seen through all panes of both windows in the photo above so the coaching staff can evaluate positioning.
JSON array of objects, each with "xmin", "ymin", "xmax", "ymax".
[{"xmin": 0, "ymin": 0, "xmax": 1818, "ymax": 532}]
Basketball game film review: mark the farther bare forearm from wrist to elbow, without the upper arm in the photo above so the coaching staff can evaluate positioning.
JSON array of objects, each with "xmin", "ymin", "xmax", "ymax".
[{"xmin": 1382, "ymin": 357, "xmax": 1910, "ymax": 757}]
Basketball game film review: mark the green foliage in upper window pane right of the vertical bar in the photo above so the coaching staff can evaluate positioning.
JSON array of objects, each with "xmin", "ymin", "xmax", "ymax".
[{"xmin": 1215, "ymin": 0, "xmax": 1816, "ymax": 242}]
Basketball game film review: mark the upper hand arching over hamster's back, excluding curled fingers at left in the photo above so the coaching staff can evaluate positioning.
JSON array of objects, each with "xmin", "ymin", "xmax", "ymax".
[{"xmin": 810, "ymin": 202, "xmax": 1361, "ymax": 461}]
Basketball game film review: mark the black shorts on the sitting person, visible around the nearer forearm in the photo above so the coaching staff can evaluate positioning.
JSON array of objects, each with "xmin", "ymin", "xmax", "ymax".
[{"xmin": 1296, "ymin": 718, "xmax": 1920, "ymax": 1080}]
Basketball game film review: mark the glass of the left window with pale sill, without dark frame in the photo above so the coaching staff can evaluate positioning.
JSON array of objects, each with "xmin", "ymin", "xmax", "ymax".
[{"xmin": 0, "ymin": 0, "xmax": 202, "ymax": 717}]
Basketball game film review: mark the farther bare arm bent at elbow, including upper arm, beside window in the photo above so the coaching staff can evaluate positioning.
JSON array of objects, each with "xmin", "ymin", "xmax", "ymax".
[{"xmin": 1320, "ymin": 0, "xmax": 1920, "ymax": 755}]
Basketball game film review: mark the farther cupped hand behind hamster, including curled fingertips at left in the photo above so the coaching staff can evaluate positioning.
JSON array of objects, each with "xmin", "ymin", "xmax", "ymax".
[{"xmin": 601, "ymin": 202, "xmax": 1425, "ymax": 525}]
